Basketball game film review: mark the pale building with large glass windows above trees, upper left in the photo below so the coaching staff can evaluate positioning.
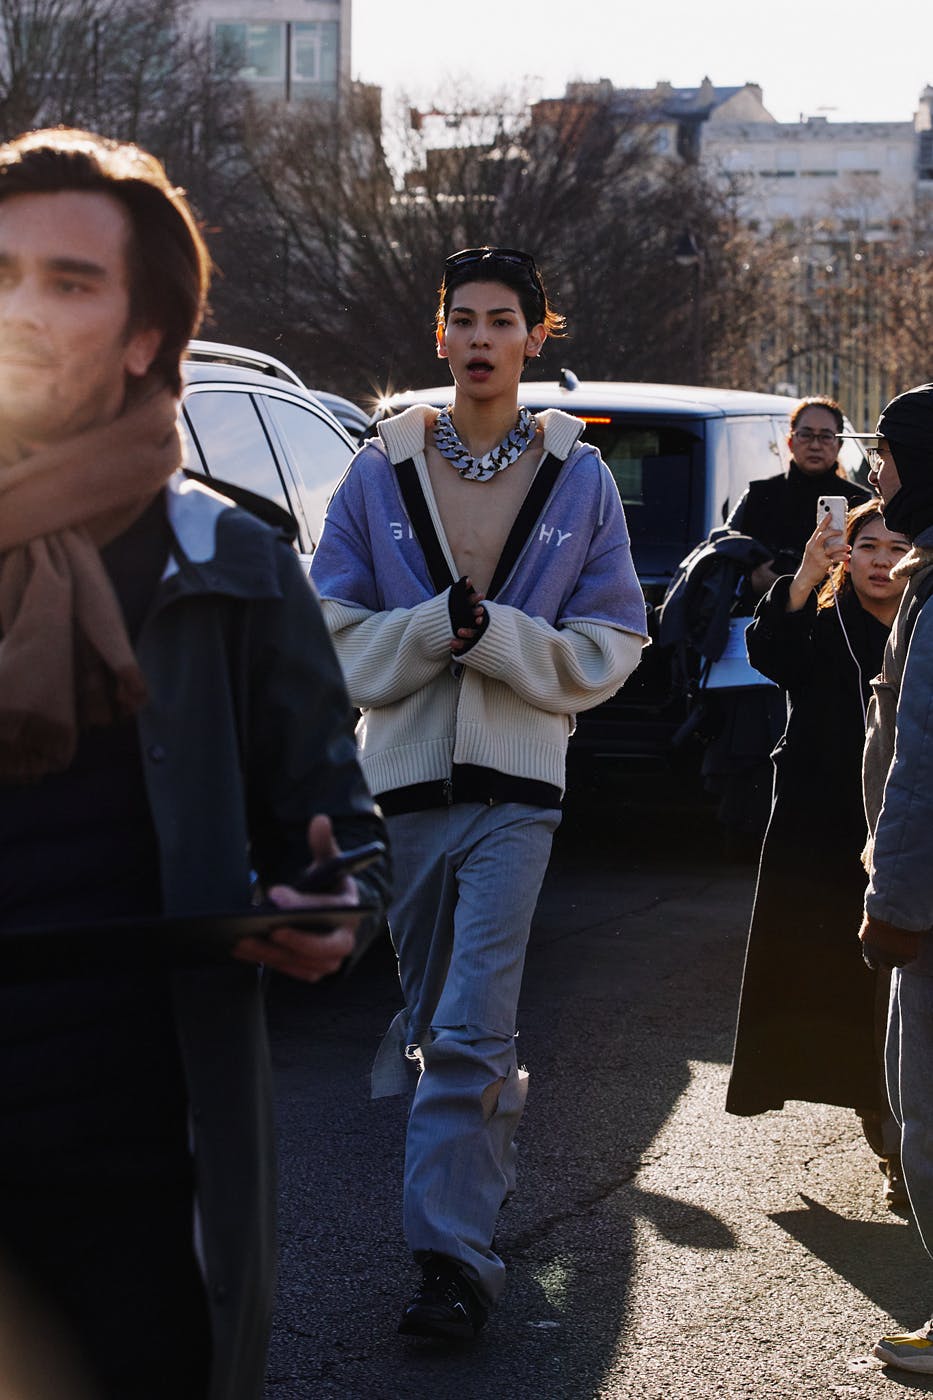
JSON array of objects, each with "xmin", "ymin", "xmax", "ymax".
[{"xmin": 193, "ymin": 0, "xmax": 352, "ymax": 102}]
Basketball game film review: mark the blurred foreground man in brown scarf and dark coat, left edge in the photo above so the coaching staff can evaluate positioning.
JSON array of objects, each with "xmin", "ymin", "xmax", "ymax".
[{"xmin": 0, "ymin": 129, "xmax": 384, "ymax": 1400}]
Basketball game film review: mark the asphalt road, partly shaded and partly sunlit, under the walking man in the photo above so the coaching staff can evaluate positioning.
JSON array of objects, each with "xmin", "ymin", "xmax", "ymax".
[{"xmin": 257, "ymin": 801, "xmax": 933, "ymax": 1400}]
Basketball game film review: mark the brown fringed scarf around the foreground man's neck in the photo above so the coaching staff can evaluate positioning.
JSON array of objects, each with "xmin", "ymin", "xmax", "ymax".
[{"xmin": 0, "ymin": 384, "xmax": 182, "ymax": 783}]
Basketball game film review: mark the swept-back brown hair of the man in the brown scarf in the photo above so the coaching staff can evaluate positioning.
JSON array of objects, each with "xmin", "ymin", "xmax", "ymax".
[{"xmin": 0, "ymin": 127, "xmax": 212, "ymax": 393}]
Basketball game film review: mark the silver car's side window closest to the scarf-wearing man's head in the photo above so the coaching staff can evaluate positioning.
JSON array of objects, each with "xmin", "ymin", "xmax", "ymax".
[{"xmin": 185, "ymin": 389, "xmax": 285, "ymax": 514}]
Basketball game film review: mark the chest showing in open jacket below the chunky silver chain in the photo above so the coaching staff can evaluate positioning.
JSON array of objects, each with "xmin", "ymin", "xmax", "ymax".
[{"xmin": 424, "ymin": 442, "xmax": 542, "ymax": 594}]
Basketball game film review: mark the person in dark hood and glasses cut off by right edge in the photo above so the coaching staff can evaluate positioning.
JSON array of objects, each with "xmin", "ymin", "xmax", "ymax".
[{"xmin": 853, "ymin": 384, "xmax": 933, "ymax": 1375}]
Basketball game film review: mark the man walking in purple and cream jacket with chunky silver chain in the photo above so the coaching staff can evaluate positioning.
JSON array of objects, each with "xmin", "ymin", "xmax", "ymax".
[{"xmin": 312, "ymin": 246, "xmax": 646, "ymax": 1337}]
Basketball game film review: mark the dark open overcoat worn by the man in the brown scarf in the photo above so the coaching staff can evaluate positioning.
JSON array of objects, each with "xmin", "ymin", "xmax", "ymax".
[{"xmin": 137, "ymin": 480, "xmax": 385, "ymax": 1400}]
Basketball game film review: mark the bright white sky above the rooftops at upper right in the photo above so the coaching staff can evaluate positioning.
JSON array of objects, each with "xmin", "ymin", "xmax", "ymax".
[{"xmin": 353, "ymin": 0, "xmax": 933, "ymax": 122}]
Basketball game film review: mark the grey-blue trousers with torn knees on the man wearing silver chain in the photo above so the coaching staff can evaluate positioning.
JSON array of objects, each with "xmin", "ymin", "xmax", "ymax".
[{"xmin": 374, "ymin": 802, "xmax": 560, "ymax": 1302}]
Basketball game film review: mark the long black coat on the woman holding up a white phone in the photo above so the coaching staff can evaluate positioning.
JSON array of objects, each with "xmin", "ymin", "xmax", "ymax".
[{"xmin": 726, "ymin": 577, "xmax": 888, "ymax": 1114}]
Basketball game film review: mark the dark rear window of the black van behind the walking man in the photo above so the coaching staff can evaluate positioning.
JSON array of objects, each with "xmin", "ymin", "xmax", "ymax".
[{"xmin": 584, "ymin": 419, "xmax": 703, "ymax": 547}]
